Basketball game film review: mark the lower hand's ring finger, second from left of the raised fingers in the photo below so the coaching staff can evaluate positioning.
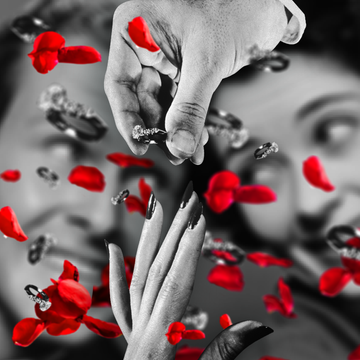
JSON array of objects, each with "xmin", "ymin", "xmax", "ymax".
[{"xmin": 130, "ymin": 193, "xmax": 163, "ymax": 325}]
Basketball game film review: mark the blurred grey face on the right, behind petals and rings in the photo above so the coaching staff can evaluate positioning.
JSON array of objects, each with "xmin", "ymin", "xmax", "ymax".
[{"xmin": 212, "ymin": 53, "xmax": 360, "ymax": 294}]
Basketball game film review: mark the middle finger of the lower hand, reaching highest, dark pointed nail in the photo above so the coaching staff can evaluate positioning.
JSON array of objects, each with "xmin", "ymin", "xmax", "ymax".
[{"xmin": 139, "ymin": 190, "xmax": 199, "ymax": 324}]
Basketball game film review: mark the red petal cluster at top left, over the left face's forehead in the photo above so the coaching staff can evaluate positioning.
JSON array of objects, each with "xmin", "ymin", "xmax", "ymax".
[{"xmin": 28, "ymin": 31, "xmax": 101, "ymax": 74}]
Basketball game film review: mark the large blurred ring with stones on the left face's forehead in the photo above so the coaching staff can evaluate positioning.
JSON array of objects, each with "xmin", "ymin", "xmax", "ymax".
[{"xmin": 38, "ymin": 84, "xmax": 108, "ymax": 141}]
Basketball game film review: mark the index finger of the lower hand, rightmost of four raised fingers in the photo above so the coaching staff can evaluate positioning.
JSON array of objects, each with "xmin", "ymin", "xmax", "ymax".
[{"xmin": 149, "ymin": 203, "xmax": 206, "ymax": 331}]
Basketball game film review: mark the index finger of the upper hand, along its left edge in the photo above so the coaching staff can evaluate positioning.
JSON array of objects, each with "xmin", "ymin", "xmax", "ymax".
[{"xmin": 104, "ymin": 3, "xmax": 148, "ymax": 155}]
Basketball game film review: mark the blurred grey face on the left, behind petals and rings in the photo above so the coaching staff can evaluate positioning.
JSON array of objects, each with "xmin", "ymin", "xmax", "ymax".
[{"xmin": 0, "ymin": 32, "xmax": 186, "ymax": 342}]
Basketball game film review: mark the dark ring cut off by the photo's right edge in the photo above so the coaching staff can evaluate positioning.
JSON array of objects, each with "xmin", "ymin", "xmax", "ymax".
[{"xmin": 326, "ymin": 225, "xmax": 360, "ymax": 260}]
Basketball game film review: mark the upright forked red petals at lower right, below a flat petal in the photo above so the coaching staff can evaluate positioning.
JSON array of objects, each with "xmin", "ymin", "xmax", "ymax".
[{"xmin": 263, "ymin": 278, "xmax": 297, "ymax": 318}]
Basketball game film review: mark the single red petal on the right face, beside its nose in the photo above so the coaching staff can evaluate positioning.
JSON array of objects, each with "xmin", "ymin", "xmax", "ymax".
[{"xmin": 303, "ymin": 156, "xmax": 335, "ymax": 192}]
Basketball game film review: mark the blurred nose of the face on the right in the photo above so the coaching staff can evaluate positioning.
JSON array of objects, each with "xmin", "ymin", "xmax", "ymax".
[{"xmin": 295, "ymin": 167, "xmax": 341, "ymax": 233}]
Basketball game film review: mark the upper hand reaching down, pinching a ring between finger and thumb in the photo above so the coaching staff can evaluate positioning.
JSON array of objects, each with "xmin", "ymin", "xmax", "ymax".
[{"xmin": 105, "ymin": 0, "xmax": 305, "ymax": 165}]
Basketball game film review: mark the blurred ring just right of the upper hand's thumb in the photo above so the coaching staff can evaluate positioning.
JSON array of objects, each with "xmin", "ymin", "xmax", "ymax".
[{"xmin": 205, "ymin": 108, "xmax": 249, "ymax": 149}]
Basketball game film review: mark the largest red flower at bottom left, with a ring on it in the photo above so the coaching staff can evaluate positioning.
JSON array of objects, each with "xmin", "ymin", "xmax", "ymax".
[{"xmin": 12, "ymin": 260, "xmax": 122, "ymax": 347}]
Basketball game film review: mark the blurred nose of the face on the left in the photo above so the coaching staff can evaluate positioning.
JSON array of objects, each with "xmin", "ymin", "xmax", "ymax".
[{"xmin": 67, "ymin": 164, "xmax": 124, "ymax": 237}]
